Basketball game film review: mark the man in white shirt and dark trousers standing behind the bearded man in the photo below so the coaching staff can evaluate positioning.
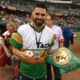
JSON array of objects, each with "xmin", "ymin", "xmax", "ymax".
[{"xmin": 46, "ymin": 14, "xmax": 64, "ymax": 80}]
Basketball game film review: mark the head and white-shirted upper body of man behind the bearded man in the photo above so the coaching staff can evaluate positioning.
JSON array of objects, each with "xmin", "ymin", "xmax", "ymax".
[{"xmin": 46, "ymin": 15, "xmax": 64, "ymax": 50}]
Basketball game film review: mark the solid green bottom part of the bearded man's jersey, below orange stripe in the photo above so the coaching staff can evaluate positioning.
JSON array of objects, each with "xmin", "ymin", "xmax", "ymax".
[{"xmin": 20, "ymin": 61, "xmax": 47, "ymax": 79}]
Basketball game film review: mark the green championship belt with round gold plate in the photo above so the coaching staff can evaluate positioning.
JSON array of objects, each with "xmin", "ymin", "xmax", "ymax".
[{"xmin": 47, "ymin": 47, "xmax": 80, "ymax": 73}]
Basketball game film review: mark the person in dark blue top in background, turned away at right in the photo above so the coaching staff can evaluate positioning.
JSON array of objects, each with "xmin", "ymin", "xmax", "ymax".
[{"xmin": 62, "ymin": 22, "xmax": 73, "ymax": 48}]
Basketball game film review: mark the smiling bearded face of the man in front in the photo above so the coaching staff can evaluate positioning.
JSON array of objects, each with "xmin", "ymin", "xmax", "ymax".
[{"xmin": 32, "ymin": 7, "xmax": 46, "ymax": 27}]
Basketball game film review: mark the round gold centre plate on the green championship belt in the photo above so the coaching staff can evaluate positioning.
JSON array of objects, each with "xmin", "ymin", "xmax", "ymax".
[{"xmin": 52, "ymin": 47, "xmax": 71, "ymax": 65}]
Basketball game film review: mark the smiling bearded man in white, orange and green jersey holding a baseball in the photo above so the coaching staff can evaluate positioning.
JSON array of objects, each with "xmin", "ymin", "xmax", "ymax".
[{"xmin": 10, "ymin": 3, "xmax": 54, "ymax": 80}]
